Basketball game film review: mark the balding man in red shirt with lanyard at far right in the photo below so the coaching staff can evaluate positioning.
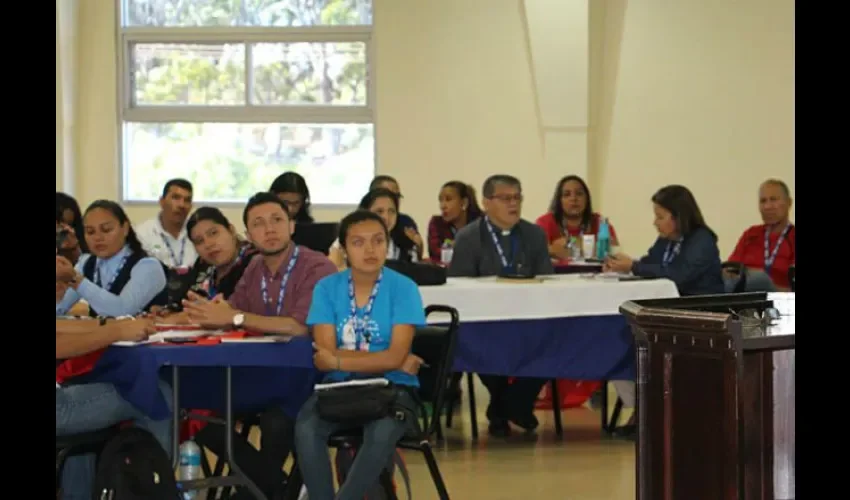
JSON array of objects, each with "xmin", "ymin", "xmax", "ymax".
[{"xmin": 728, "ymin": 179, "xmax": 797, "ymax": 291}]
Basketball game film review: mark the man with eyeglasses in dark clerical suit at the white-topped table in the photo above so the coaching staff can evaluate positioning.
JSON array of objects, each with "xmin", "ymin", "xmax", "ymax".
[{"xmin": 448, "ymin": 175, "xmax": 555, "ymax": 436}]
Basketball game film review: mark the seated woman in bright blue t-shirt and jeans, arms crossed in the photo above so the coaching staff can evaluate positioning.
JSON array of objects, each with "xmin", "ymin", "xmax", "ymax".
[{"xmin": 295, "ymin": 210, "xmax": 425, "ymax": 500}]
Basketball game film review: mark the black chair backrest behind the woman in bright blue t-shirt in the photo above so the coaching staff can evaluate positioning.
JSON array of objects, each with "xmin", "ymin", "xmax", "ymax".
[{"xmin": 417, "ymin": 304, "xmax": 460, "ymax": 437}]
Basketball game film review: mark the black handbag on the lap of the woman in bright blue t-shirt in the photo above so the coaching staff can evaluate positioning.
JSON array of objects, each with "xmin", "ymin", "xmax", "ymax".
[{"xmin": 316, "ymin": 383, "xmax": 407, "ymax": 426}]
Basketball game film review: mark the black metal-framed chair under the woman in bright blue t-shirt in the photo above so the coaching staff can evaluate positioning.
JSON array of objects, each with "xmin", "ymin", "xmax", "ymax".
[{"xmin": 286, "ymin": 305, "xmax": 460, "ymax": 500}]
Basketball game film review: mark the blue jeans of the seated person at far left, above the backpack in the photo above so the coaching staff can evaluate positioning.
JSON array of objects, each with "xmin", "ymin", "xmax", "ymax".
[{"xmin": 56, "ymin": 382, "xmax": 172, "ymax": 500}]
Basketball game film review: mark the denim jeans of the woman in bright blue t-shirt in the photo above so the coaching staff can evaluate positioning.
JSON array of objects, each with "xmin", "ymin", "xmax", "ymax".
[{"xmin": 295, "ymin": 389, "xmax": 418, "ymax": 500}]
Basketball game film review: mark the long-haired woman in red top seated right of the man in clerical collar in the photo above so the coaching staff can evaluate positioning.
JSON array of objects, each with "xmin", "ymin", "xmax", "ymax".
[{"xmin": 537, "ymin": 175, "xmax": 619, "ymax": 262}]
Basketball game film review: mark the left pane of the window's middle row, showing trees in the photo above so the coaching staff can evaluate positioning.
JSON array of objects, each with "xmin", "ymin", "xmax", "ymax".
[{"xmin": 132, "ymin": 43, "xmax": 245, "ymax": 106}]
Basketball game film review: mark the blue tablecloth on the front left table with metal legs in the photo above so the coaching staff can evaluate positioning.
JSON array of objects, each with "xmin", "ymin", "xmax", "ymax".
[{"xmin": 86, "ymin": 338, "xmax": 320, "ymax": 419}]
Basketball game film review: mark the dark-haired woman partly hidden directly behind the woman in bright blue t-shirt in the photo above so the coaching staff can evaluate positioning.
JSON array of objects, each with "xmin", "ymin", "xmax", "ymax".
[{"xmin": 328, "ymin": 188, "xmax": 419, "ymax": 270}]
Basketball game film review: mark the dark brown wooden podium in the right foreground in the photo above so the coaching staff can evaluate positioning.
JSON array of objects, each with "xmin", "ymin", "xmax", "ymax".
[{"xmin": 620, "ymin": 293, "xmax": 795, "ymax": 500}]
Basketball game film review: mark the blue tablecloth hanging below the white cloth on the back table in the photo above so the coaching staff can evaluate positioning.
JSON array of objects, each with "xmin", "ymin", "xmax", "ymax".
[{"xmin": 454, "ymin": 315, "xmax": 635, "ymax": 380}]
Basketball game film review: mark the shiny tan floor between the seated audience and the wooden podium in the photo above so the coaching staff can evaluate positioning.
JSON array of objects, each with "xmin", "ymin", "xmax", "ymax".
[{"xmin": 219, "ymin": 384, "xmax": 635, "ymax": 500}]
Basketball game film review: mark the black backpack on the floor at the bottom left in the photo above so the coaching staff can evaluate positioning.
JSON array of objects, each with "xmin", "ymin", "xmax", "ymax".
[{"xmin": 93, "ymin": 427, "xmax": 180, "ymax": 500}]
